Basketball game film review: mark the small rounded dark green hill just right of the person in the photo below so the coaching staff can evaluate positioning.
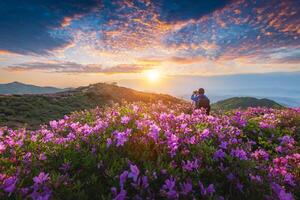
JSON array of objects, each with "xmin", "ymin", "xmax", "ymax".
[{"xmin": 212, "ymin": 97, "xmax": 283, "ymax": 110}]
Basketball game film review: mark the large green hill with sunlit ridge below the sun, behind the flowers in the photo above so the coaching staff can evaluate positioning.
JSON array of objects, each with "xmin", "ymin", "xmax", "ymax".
[{"xmin": 0, "ymin": 83, "xmax": 182, "ymax": 128}]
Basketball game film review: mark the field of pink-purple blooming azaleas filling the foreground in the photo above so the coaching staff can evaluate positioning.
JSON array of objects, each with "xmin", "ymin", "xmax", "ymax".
[{"xmin": 0, "ymin": 103, "xmax": 300, "ymax": 200}]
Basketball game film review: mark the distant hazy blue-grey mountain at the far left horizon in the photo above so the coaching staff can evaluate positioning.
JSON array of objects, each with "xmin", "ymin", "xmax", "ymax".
[{"xmin": 0, "ymin": 82, "xmax": 66, "ymax": 94}]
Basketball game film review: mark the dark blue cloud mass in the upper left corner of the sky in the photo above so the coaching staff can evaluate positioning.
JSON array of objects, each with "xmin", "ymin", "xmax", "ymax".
[{"xmin": 0, "ymin": 0, "xmax": 99, "ymax": 54}]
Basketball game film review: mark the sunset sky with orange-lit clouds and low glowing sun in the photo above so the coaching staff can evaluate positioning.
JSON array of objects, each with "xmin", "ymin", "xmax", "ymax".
[{"xmin": 0, "ymin": 0, "xmax": 300, "ymax": 87}]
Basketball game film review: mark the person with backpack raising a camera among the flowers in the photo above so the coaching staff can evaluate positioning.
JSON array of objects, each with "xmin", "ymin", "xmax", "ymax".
[{"xmin": 191, "ymin": 88, "xmax": 210, "ymax": 115}]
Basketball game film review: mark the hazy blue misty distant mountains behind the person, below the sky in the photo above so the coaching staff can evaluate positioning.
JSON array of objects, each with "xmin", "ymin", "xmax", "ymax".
[{"xmin": 118, "ymin": 72, "xmax": 300, "ymax": 107}]
